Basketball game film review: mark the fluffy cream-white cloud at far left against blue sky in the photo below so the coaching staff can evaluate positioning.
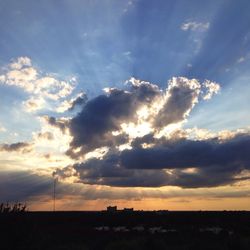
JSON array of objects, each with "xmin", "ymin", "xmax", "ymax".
[{"xmin": 0, "ymin": 57, "xmax": 75, "ymax": 112}]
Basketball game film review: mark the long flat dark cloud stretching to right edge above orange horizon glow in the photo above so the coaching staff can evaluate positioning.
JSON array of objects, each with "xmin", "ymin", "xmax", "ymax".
[{"xmin": 55, "ymin": 134, "xmax": 250, "ymax": 188}]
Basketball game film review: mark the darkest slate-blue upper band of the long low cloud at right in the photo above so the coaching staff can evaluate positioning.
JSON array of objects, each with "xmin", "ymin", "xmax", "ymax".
[{"xmin": 121, "ymin": 134, "xmax": 250, "ymax": 169}]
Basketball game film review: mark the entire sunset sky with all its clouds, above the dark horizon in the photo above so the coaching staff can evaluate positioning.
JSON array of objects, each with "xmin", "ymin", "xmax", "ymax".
[{"xmin": 0, "ymin": 0, "xmax": 250, "ymax": 210}]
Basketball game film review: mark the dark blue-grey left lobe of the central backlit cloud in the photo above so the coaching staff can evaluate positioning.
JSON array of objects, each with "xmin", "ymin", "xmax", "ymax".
[{"xmin": 68, "ymin": 83, "xmax": 161, "ymax": 156}]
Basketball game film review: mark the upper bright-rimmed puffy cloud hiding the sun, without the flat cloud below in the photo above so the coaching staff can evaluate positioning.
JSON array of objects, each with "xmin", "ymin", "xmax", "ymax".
[{"xmin": 60, "ymin": 77, "xmax": 217, "ymax": 158}]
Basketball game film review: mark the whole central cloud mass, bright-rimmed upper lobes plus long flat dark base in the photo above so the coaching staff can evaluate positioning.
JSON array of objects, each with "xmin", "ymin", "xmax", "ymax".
[{"xmin": 50, "ymin": 77, "xmax": 250, "ymax": 188}]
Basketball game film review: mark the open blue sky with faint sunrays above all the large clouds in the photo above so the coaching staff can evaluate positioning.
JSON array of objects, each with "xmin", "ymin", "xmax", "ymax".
[{"xmin": 0, "ymin": 0, "xmax": 250, "ymax": 135}]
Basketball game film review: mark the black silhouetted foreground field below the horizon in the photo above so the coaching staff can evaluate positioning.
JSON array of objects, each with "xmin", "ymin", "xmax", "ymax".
[{"xmin": 0, "ymin": 212, "xmax": 250, "ymax": 250}]
